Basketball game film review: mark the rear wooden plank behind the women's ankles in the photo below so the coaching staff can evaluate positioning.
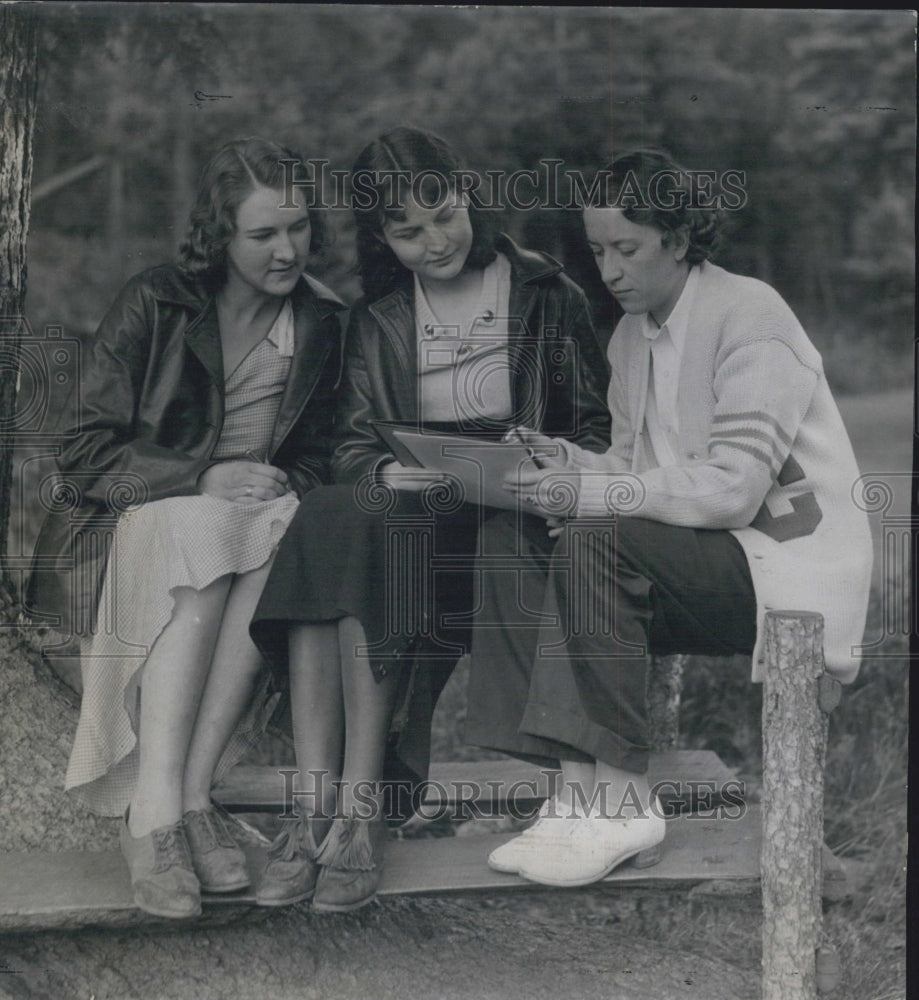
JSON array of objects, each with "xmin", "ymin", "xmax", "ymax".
[{"xmin": 214, "ymin": 750, "xmax": 743, "ymax": 813}]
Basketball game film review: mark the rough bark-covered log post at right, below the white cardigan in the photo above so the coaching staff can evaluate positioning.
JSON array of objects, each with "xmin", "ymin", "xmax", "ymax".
[{"xmin": 762, "ymin": 611, "xmax": 827, "ymax": 1000}]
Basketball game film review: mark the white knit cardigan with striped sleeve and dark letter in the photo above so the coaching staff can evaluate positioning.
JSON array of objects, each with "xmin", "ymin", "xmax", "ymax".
[{"xmin": 562, "ymin": 263, "xmax": 872, "ymax": 683}]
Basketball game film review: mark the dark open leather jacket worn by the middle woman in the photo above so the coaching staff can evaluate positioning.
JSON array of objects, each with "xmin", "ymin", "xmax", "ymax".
[{"xmin": 332, "ymin": 236, "xmax": 610, "ymax": 483}]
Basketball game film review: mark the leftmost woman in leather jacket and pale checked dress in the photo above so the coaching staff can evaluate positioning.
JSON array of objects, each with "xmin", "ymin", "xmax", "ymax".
[{"xmin": 27, "ymin": 139, "xmax": 342, "ymax": 917}]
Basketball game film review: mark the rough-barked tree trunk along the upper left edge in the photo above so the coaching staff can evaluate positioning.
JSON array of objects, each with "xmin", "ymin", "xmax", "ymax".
[{"xmin": 0, "ymin": 4, "xmax": 38, "ymax": 586}]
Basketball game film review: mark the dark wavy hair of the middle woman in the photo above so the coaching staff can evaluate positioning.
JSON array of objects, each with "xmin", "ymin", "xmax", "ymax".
[{"xmin": 351, "ymin": 126, "xmax": 495, "ymax": 302}]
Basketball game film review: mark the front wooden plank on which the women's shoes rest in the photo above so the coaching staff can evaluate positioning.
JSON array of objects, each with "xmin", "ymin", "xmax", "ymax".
[{"xmin": 0, "ymin": 806, "xmax": 761, "ymax": 933}]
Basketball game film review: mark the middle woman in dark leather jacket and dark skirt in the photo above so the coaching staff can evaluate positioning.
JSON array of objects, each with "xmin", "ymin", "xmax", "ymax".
[{"xmin": 251, "ymin": 128, "xmax": 609, "ymax": 911}]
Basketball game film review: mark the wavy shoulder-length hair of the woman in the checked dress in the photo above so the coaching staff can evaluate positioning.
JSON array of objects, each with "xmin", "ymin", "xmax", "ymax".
[{"xmin": 179, "ymin": 137, "xmax": 326, "ymax": 290}]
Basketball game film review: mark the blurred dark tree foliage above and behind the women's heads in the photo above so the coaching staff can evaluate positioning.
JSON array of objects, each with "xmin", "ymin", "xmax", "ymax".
[{"xmin": 25, "ymin": 4, "xmax": 915, "ymax": 370}]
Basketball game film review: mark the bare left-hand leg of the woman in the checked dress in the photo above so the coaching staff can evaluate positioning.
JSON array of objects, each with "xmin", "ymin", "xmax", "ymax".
[{"xmin": 130, "ymin": 576, "xmax": 232, "ymax": 837}]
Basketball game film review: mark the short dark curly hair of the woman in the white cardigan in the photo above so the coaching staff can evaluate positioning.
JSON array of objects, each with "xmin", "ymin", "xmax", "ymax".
[{"xmin": 607, "ymin": 149, "xmax": 722, "ymax": 264}]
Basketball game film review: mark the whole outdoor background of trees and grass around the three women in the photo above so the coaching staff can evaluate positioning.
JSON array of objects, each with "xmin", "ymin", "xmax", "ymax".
[{"xmin": 8, "ymin": 3, "xmax": 916, "ymax": 1000}]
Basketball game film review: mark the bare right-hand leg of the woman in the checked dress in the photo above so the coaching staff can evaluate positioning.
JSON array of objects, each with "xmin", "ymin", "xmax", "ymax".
[{"xmin": 182, "ymin": 559, "xmax": 274, "ymax": 811}]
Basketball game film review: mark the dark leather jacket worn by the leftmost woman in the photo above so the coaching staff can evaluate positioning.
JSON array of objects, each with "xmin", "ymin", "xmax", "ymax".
[{"xmin": 24, "ymin": 266, "xmax": 344, "ymax": 632}]
